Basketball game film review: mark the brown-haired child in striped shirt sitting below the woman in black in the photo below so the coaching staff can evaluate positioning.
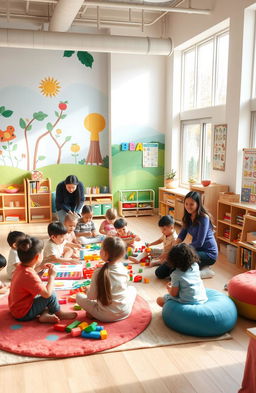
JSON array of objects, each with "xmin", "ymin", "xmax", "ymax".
[{"xmin": 75, "ymin": 205, "xmax": 104, "ymax": 244}]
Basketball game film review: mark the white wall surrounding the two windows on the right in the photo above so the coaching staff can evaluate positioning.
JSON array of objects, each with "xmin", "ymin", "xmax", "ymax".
[{"xmin": 166, "ymin": 0, "xmax": 255, "ymax": 192}]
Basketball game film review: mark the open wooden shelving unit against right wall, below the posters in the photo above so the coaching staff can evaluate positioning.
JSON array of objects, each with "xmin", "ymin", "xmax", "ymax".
[{"xmin": 217, "ymin": 201, "xmax": 256, "ymax": 270}]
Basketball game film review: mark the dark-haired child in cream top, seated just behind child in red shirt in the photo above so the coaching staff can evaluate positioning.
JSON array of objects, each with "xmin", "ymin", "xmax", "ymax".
[{"xmin": 42, "ymin": 221, "xmax": 78, "ymax": 265}]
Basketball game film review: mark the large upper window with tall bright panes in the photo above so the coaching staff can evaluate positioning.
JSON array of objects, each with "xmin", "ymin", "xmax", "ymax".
[{"xmin": 182, "ymin": 31, "xmax": 229, "ymax": 111}]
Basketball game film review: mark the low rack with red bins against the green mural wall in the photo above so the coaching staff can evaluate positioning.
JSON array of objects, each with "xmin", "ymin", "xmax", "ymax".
[{"xmin": 118, "ymin": 189, "xmax": 155, "ymax": 217}]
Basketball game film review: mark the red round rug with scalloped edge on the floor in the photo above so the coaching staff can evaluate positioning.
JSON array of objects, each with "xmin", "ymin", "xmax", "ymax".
[{"xmin": 0, "ymin": 292, "xmax": 152, "ymax": 358}]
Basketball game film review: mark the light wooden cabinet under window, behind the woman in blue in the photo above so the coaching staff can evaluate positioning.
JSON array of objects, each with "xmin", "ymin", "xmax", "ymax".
[{"xmin": 159, "ymin": 183, "xmax": 229, "ymax": 224}]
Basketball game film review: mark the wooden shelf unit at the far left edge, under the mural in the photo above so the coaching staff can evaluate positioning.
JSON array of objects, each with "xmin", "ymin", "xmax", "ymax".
[{"xmin": 0, "ymin": 180, "xmax": 27, "ymax": 224}]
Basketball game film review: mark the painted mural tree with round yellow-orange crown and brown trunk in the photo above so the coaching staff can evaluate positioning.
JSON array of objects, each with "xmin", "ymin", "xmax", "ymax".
[{"xmin": 84, "ymin": 113, "xmax": 106, "ymax": 165}]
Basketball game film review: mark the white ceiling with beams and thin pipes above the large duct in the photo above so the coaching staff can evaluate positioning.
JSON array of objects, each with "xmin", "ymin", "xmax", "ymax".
[{"xmin": 0, "ymin": 0, "xmax": 210, "ymax": 32}]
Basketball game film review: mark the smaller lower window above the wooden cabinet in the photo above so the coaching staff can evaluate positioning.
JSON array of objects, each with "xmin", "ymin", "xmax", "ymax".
[{"xmin": 181, "ymin": 119, "xmax": 212, "ymax": 185}]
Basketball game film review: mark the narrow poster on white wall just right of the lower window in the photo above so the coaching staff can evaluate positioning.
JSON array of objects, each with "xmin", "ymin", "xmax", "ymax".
[{"xmin": 213, "ymin": 124, "xmax": 227, "ymax": 171}]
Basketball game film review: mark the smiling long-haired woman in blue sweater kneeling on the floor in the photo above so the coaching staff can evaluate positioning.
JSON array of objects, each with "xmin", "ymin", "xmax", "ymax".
[{"xmin": 176, "ymin": 191, "xmax": 218, "ymax": 278}]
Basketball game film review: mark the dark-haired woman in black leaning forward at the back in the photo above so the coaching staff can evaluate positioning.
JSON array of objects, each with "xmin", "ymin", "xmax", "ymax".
[{"xmin": 56, "ymin": 175, "xmax": 84, "ymax": 223}]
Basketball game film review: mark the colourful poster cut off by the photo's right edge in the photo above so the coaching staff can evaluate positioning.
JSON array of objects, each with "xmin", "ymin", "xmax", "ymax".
[{"xmin": 241, "ymin": 149, "xmax": 256, "ymax": 203}]
